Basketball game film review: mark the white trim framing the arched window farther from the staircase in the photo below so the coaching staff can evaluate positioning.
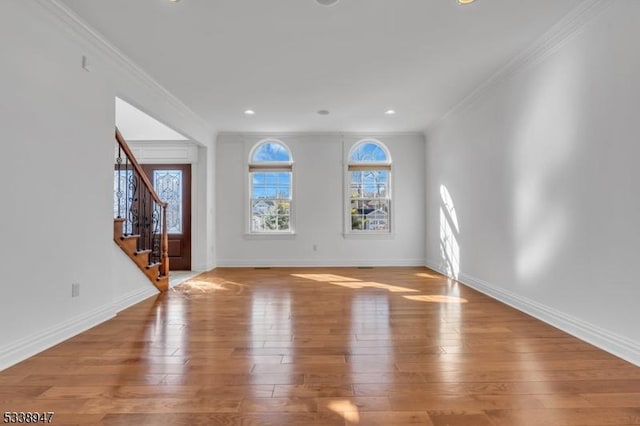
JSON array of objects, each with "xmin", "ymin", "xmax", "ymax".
[{"xmin": 342, "ymin": 138, "xmax": 396, "ymax": 240}]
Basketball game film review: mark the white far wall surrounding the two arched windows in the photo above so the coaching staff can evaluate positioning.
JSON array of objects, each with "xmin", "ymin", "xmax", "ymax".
[{"xmin": 216, "ymin": 134, "xmax": 424, "ymax": 266}]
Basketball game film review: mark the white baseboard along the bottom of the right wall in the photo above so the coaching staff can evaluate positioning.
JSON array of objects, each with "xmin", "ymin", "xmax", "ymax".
[{"xmin": 426, "ymin": 259, "xmax": 640, "ymax": 366}]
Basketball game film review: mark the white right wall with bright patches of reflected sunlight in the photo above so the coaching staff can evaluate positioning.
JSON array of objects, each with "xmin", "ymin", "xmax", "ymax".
[{"xmin": 426, "ymin": 0, "xmax": 640, "ymax": 365}]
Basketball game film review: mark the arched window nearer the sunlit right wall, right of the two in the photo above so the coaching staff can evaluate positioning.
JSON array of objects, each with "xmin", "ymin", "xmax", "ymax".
[{"xmin": 347, "ymin": 140, "xmax": 392, "ymax": 233}]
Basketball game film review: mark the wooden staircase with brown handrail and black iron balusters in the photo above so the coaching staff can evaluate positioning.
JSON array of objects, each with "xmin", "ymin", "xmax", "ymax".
[{"xmin": 113, "ymin": 128, "xmax": 169, "ymax": 292}]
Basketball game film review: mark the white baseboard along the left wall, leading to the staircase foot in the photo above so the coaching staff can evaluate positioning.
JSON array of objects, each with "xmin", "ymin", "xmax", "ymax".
[{"xmin": 0, "ymin": 304, "xmax": 116, "ymax": 371}]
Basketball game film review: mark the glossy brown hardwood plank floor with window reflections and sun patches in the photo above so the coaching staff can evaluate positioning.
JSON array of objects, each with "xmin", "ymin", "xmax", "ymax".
[{"xmin": 0, "ymin": 268, "xmax": 640, "ymax": 426}]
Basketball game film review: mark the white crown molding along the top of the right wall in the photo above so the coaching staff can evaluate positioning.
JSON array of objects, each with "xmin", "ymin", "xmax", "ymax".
[{"xmin": 424, "ymin": 0, "xmax": 612, "ymax": 137}]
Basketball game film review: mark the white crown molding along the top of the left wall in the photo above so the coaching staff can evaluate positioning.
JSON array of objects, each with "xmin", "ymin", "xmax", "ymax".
[{"xmin": 35, "ymin": 0, "xmax": 215, "ymax": 134}]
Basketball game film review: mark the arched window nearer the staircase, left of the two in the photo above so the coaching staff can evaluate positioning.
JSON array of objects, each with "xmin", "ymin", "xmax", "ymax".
[{"xmin": 249, "ymin": 140, "xmax": 293, "ymax": 234}]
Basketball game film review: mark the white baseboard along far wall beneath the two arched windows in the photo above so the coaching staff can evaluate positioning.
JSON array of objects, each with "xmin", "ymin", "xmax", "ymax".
[{"xmin": 217, "ymin": 259, "xmax": 424, "ymax": 268}]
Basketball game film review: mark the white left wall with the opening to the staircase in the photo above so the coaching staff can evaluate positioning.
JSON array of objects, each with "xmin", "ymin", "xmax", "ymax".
[{"xmin": 0, "ymin": 0, "xmax": 212, "ymax": 369}]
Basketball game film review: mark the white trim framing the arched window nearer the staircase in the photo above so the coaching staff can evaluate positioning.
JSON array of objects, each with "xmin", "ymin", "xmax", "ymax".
[{"xmin": 244, "ymin": 138, "xmax": 296, "ymax": 240}]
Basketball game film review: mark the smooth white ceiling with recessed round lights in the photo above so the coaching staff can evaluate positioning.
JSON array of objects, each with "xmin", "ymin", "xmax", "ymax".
[{"xmin": 63, "ymin": 0, "xmax": 584, "ymax": 132}]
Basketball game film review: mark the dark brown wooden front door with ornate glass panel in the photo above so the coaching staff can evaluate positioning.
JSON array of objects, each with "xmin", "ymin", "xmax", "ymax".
[{"xmin": 142, "ymin": 164, "xmax": 191, "ymax": 271}]
